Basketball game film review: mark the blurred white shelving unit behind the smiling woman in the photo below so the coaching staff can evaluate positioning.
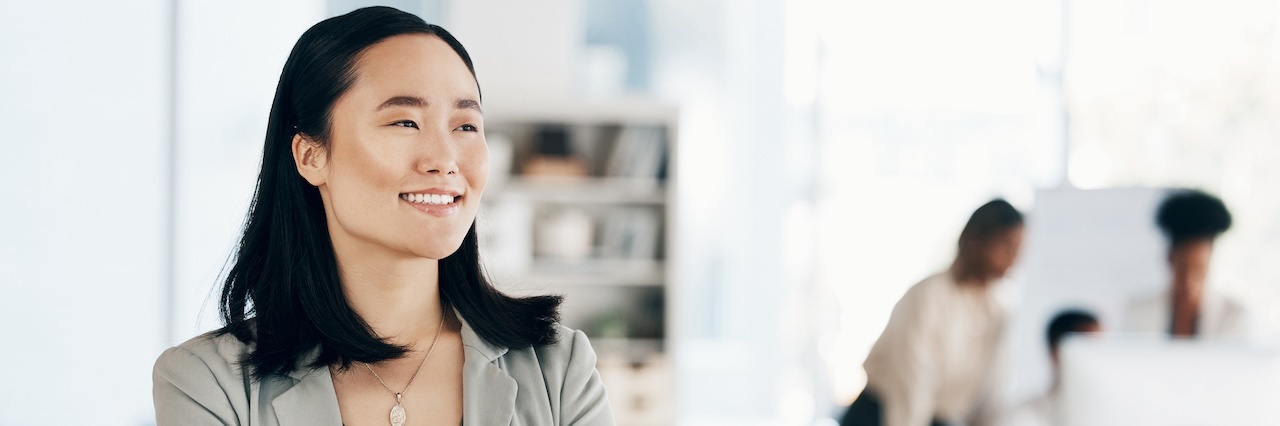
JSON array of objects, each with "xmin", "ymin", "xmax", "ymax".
[{"xmin": 477, "ymin": 100, "xmax": 677, "ymax": 425}]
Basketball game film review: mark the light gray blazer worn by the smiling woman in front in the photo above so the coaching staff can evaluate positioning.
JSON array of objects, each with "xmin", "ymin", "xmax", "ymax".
[{"xmin": 152, "ymin": 316, "xmax": 613, "ymax": 426}]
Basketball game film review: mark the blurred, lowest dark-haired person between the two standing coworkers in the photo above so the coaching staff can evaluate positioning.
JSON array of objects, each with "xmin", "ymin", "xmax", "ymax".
[{"xmin": 1000, "ymin": 310, "xmax": 1102, "ymax": 426}]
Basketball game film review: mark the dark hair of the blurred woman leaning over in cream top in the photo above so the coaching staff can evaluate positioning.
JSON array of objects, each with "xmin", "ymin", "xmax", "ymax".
[{"xmin": 954, "ymin": 198, "xmax": 1024, "ymax": 280}]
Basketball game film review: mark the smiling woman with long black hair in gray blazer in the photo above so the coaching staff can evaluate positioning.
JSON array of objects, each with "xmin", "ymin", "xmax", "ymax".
[{"xmin": 152, "ymin": 8, "xmax": 613, "ymax": 426}]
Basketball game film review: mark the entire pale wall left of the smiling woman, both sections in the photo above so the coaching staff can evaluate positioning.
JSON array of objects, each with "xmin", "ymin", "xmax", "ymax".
[{"xmin": 0, "ymin": 0, "xmax": 325, "ymax": 425}]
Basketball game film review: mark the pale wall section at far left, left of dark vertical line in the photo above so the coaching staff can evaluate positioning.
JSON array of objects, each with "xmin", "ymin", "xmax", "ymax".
[{"xmin": 0, "ymin": 0, "xmax": 169, "ymax": 425}]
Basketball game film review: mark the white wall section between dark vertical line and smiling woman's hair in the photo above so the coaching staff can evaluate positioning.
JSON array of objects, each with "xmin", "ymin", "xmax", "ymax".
[{"xmin": 166, "ymin": 0, "xmax": 326, "ymax": 344}]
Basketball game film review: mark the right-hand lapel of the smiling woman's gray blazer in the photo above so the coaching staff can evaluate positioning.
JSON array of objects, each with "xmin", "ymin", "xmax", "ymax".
[{"xmin": 457, "ymin": 315, "xmax": 517, "ymax": 426}]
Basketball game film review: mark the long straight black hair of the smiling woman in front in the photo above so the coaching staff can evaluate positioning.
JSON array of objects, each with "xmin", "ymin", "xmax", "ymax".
[{"xmin": 219, "ymin": 6, "xmax": 561, "ymax": 379}]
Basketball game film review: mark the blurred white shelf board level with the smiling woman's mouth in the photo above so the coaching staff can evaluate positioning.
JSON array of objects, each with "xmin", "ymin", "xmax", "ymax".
[{"xmin": 486, "ymin": 177, "xmax": 667, "ymax": 205}]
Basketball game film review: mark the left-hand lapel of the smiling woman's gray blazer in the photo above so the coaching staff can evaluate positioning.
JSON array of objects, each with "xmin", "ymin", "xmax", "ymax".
[{"xmin": 271, "ymin": 355, "xmax": 342, "ymax": 425}]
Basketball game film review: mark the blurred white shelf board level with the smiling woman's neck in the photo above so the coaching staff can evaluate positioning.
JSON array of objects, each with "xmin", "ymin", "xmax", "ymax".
[{"xmin": 493, "ymin": 258, "xmax": 667, "ymax": 288}]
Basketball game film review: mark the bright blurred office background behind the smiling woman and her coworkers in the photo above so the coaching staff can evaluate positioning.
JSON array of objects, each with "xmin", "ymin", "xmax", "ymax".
[{"xmin": 0, "ymin": 0, "xmax": 1280, "ymax": 425}]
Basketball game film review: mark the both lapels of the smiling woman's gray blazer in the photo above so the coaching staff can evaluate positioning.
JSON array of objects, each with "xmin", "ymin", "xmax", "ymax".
[{"xmin": 271, "ymin": 311, "xmax": 517, "ymax": 426}]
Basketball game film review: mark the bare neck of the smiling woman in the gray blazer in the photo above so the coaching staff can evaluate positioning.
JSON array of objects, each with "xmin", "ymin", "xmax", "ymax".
[{"xmin": 334, "ymin": 232, "xmax": 443, "ymax": 348}]
